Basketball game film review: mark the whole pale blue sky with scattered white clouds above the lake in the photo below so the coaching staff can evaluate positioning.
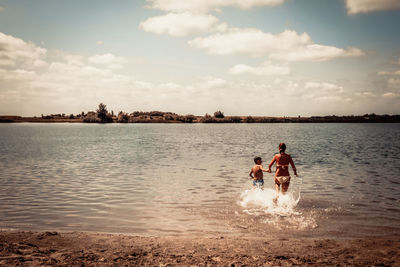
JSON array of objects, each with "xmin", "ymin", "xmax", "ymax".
[{"xmin": 0, "ymin": 0, "xmax": 400, "ymax": 116}]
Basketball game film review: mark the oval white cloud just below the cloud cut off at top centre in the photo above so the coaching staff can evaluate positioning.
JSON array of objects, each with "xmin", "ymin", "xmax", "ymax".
[{"xmin": 139, "ymin": 12, "xmax": 222, "ymax": 36}]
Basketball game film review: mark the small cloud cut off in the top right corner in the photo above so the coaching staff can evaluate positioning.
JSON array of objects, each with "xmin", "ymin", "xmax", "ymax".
[{"xmin": 346, "ymin": 0, "xmax": 400, "ymax": 14}]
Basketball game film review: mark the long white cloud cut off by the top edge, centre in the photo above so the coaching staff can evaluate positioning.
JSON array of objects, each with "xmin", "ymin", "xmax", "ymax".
[{"xmin": 147, "ymin": 0, "xmax": 285, "ymax": 13}]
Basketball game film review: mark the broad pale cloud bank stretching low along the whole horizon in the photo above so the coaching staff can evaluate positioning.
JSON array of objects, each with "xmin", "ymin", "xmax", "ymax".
[{"xmin": 0, "ymin": 31, "xmax": 400, "ymax": 116}]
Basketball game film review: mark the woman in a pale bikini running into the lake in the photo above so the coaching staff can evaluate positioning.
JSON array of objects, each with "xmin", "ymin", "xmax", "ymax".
[{"xmin": 268, "ymin": 143, "xmax": 297, "ymax": 194}]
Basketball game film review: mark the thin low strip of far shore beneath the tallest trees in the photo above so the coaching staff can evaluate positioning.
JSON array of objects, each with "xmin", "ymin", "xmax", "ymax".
[{"xmin": 0, "ymin": 114, "xmax": 400, "ymax": 123}]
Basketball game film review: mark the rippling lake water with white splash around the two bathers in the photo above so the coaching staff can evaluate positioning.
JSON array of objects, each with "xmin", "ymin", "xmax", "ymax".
[{"xmin": 0, "ymin": 123, "xmax": 400, "ymax": 237}]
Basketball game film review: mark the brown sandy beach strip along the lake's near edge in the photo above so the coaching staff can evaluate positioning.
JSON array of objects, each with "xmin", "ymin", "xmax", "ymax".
[{"xmin": 0, "ymin": 231, "xmax": 400, "ymax": 266}]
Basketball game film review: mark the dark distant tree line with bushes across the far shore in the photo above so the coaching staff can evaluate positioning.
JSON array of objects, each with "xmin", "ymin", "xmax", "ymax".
[{"xmin": 7, "ymin": 103, "xmax": 394, "ymax": 123}]
